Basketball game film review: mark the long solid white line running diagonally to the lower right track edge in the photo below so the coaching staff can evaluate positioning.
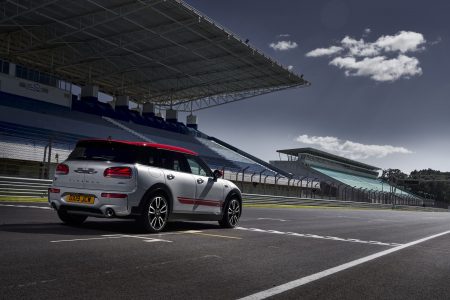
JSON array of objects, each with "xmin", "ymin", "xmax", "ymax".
[{"xmin": 239, "ymin": 230, "xmax": 450, "ymax": 300}]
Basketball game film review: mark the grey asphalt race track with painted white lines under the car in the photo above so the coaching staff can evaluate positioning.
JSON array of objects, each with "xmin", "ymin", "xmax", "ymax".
[{"xmin": 0, "ymin": 202, "xmax": 450, "ymax": 299}]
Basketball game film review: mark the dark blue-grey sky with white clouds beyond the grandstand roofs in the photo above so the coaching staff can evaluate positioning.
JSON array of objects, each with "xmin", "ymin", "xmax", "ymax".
[{"xmin": 182, "ymin": 0, "xmax": 450, "ymax": 173}]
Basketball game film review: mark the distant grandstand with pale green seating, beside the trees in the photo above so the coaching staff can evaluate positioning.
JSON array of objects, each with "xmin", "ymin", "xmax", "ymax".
[{"xmin": 270, "ymin": 148, "xmax": 433, "ymax": 206}]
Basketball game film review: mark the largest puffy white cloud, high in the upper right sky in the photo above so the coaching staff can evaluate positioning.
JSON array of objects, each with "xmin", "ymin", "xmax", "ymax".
[{"xmin": 306, "ymin": 28, "xmax": 426, "ymax": 81}]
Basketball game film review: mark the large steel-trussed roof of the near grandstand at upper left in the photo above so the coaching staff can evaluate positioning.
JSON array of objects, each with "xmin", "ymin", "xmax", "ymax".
[{"xmin": 0, "ymin": 0, "xmax": 309, "ymax": 111}]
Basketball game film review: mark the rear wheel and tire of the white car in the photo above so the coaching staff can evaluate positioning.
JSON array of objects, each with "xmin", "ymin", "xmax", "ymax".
[{"xmin": 137, "ymin": 194, "xmax": 169, "ymax": 233}]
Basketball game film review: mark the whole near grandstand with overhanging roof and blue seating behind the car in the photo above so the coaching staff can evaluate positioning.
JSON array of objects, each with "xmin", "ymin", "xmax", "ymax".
[{"xmin": 0, "ymin": 0, "xmax": 309, "ymax": 197}]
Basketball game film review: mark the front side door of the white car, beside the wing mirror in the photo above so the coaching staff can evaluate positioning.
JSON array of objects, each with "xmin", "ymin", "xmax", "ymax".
[{"xmin": 187, "ymin": 156, "xmax": 224, "ymax": 214}]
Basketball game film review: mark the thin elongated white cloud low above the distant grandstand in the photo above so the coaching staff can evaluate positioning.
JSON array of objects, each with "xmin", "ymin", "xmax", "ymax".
[{"xmin": 296, "ymin": 134, "xmax": 412, "ymax": 159}]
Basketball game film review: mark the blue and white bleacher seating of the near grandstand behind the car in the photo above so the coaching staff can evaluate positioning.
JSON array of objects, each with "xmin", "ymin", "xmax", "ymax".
[{"xmin": 0, "ymin": 91, "xmax": 282, "ymax": 176}]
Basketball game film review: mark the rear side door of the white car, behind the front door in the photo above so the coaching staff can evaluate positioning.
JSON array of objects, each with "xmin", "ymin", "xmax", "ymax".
[{"xmin": 160, "ymin": 150, "xmax": 196, "ymax": 213}]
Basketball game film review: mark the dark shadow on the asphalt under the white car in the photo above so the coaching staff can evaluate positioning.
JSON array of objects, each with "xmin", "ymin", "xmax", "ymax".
[{"xmin": 0, "ymin": 219, "xmax": 220, "ymax": 236}]
